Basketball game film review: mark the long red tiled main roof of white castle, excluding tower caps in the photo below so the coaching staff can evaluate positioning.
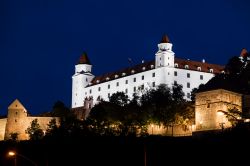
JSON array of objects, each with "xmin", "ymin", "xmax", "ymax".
[{"xmin": 89, "ymin": 58, "xmax": 224, "ymax": 86}]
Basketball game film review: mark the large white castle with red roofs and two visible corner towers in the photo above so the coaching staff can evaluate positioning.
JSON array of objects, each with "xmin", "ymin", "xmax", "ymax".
[{"xmin": 72, "ymin": 36, "xmax": 224, "ymax": 108}]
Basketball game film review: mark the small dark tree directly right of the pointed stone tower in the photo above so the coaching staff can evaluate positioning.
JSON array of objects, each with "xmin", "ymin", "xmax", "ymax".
[{"xmin": 25, "ymin": 119, "xmax": 44, "ymax": 141}]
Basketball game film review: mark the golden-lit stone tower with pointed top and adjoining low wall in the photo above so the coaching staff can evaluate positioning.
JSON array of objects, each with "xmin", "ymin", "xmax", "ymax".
[{"xmin": 0, "ymin": 99, "xmax": 59, "ymax": 141}]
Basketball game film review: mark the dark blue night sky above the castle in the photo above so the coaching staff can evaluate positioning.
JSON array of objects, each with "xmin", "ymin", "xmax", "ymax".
[{"xmin": 0, "ymin": 0, "xmax": 250, "ymax": 114}]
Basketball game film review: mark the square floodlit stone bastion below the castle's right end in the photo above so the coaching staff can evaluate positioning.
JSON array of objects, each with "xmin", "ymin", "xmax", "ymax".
[{"xmin": 195, "ymin": 89, "xmax": 242, "ymax": 130}]
